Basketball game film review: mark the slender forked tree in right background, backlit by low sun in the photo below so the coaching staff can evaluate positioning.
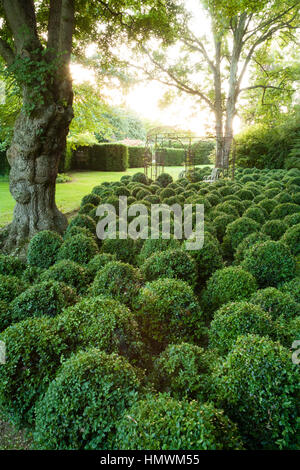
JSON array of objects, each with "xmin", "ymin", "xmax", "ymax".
[{"xmin": 123, "ymin": 0, "xmax": 299, "ymax": 167}]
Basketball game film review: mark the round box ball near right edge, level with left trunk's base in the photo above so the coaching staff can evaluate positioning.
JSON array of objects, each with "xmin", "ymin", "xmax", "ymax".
[{"xmin": 242, "ymin": 240, "xmax": 296, "ymax": 287}]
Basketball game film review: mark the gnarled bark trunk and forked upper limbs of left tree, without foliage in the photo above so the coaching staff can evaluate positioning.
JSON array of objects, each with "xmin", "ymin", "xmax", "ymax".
[{"xmin": 0, "ymin": 0, "xmax": 74, "ymax": 252}]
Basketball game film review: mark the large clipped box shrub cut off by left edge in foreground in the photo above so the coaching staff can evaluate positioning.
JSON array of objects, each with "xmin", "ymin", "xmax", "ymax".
[{"xmin": 0, "ymin": 317, "xmax": 76, "ymax": 427}]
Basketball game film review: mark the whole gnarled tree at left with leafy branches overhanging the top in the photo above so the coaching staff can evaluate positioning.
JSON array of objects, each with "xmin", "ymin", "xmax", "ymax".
[{"xmin": 0, "ymin": 0, "xmax": 180, "ymax": 251}]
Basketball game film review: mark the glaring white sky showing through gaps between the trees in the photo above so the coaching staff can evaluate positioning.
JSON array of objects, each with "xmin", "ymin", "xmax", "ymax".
[{"xmin": 72, "ymin": 0, "xmax": 240, "ymax": 136}]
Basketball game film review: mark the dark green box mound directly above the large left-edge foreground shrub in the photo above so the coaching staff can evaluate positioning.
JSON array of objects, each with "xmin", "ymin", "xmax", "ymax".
[{"xmin": 9, "ymin": 280, "xmax": 78, "ymax": 324}]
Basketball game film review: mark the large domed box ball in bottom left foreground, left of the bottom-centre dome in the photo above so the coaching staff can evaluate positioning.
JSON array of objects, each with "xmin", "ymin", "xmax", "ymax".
[{"xmin": 35, "ymin": 349, "xmax": 142, "ymax": 450}]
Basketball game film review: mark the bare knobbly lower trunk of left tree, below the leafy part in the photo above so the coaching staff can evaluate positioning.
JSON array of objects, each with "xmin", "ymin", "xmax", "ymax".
[{"xmin": 4, "ymin": 84, "xmax": 73, "ymax": 252}]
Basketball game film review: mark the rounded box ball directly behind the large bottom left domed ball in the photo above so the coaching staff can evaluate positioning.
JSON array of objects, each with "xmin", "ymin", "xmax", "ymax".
[{"xmin": 59, "ymin": 295, "xmax": 144, "ymax": 364}]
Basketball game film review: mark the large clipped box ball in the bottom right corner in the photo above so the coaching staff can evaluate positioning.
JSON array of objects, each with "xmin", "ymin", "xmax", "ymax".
[{"xmin": 213, "ymin": 335, "xmax": 300, "ymax": 449}]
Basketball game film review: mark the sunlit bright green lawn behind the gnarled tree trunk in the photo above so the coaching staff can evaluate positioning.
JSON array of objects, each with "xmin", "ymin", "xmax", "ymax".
[{"xmin": 0, "ymin": 165, "xmax": 207, "ymax": 227}]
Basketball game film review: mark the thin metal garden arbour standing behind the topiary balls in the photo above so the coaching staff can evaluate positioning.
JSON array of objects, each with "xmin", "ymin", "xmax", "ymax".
[{"xmin": 144, "ymin": 127, "xmax": 216, "ymax": 179}]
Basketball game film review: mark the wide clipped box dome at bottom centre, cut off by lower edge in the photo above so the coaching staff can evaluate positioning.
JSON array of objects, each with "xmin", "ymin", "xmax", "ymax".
[{"xmin": 115, "ymin": 394, "xmax": 243, "ymax": 451}]
